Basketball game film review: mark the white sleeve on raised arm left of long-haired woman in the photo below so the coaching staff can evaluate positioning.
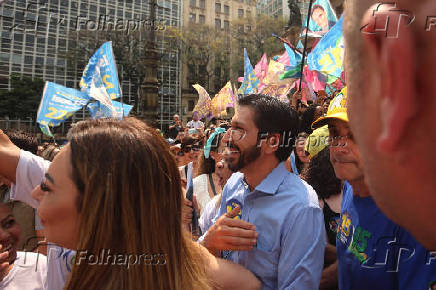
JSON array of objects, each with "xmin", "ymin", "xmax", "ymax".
[{"xmin": 11, "ymin": 150, "xmax": 50, "ymax": 208}]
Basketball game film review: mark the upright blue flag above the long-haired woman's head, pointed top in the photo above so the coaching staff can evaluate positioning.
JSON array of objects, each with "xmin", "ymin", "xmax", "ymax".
[{"xmin": 80, "ymin": 41, "xmax": 122, "ymax": 117}]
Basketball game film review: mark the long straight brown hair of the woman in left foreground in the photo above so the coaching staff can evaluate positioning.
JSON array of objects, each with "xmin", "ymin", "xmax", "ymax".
[{"xmin": 65, "ymin": 118, "xmax": 211, "ymax": 290}]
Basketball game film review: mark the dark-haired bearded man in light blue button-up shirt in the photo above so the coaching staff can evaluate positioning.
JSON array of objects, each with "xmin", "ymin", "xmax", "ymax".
[{"xmin": 200, "ymin": 95, "xmax": 326, "ymax": 289}]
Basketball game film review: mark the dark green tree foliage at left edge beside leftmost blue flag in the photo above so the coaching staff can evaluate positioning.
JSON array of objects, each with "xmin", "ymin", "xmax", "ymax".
[{"xmin": 0, "ymin": 74, "xmax": 44, "ymax": 120}]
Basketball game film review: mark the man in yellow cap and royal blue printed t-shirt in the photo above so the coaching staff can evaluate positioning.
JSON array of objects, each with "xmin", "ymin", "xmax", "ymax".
[{"xmin": 312, "ymin": 88, "xmax": 436, "ymax": 290}]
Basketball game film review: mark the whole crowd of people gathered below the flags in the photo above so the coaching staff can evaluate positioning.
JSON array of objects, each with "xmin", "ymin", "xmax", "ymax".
[{"xmin": 0, "ymin": 0, "xmax": 436, "ymax": 290}]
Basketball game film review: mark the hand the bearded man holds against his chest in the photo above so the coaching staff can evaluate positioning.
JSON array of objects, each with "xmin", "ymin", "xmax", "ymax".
[{"xmin": 203, "ymin": 206, "xmax": 258, "ymax": 254}]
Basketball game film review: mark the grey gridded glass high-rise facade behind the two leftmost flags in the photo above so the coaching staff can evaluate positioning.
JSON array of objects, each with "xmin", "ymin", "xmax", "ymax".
[{"xmin": 0, "ymin": 0, "xmax": 182, "ymax": 126}]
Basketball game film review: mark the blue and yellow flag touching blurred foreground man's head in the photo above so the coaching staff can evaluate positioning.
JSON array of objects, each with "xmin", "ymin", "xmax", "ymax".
[{"xmin": 307, "ymin": 15, "xmax": 345, "ymax": 78}]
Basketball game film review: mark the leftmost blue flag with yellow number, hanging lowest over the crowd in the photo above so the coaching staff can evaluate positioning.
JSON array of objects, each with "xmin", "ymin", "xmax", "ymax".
[{"xmin": 36, "ymin": 82, "xmax": 90, "ymax": 136}]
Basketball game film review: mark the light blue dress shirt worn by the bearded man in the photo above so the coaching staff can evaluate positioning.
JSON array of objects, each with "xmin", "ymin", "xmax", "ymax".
[{"xmin": 206, "ymin": 162, "xmax": 326, "ymax": 290}]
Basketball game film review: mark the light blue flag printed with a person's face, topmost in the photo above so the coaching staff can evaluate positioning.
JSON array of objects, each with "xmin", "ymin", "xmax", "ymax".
[{"xmin": 301, "ymin": 0, "xmax": 338, "ymax": 36}]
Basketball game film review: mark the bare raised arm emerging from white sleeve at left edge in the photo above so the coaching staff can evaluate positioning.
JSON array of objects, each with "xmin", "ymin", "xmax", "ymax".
[{"xmin": 0, "ymin": 130, "xmax": 20, "ymax": 183}]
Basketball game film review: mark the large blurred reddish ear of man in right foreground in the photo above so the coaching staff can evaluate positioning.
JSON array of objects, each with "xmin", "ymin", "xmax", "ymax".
[{"xmin": 363, "ymin": 7, "xmax": 418, "ymax": 152}]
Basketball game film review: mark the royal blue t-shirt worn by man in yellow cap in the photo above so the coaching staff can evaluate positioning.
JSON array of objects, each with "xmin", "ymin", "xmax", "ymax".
[{"xmin": 336, "ymin": 182, "xmax": 436, "ymax": 290}]
